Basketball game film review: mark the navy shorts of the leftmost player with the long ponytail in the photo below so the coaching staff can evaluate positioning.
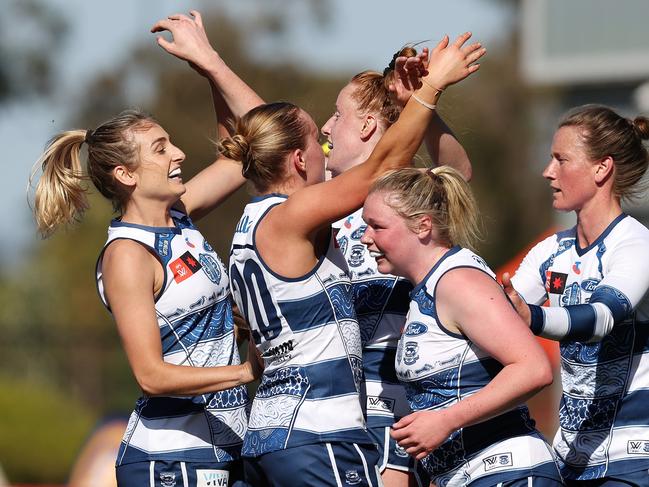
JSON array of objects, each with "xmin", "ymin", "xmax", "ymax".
[{"xmin": 115, "ymin": 460, "xmax": 250, "ymax": 487}]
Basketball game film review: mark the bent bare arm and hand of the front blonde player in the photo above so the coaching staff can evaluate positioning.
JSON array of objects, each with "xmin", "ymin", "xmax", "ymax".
[{"xmin": 392, "ymin": 268, "xmax": 552, "ymax": 459}]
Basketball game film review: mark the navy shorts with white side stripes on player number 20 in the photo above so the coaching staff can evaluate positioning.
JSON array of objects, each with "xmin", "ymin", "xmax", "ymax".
[{"xmin": 243, "ymin": 443, "xmax": 382, "ymax": 487}]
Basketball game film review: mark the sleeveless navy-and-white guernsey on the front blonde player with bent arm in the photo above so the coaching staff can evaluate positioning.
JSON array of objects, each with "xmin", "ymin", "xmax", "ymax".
[{"xmin": 396, "ymin": 247, "xmax": 561, "ymax": 487}]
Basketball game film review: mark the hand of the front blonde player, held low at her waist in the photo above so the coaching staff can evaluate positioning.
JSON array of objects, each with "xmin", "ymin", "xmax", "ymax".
[{"xmin": 390, "ymin": 410, "xmax": 455, "ymax": 460}]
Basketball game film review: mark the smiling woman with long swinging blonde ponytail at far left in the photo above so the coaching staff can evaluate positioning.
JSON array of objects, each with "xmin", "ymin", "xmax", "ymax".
[{"xmin": 28, "ymin": 10, "xmax": 270, "ymax": 487}]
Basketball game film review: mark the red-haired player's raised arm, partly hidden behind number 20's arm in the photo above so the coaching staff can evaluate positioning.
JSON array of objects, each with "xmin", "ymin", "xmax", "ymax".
[{"xmin": 388, "ymin": 48, "xmax": 472, "ymax": 181}]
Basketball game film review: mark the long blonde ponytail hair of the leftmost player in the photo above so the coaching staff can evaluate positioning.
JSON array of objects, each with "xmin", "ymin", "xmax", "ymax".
[{"xmin": 30, "ymin": 110, "xmax": 156, "ymax": 237}]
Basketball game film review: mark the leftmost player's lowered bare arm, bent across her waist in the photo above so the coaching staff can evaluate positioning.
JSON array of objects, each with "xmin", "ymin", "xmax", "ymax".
[{"xmin": 102, "ymin": 240, "xmax": 258, "ymax": 396}]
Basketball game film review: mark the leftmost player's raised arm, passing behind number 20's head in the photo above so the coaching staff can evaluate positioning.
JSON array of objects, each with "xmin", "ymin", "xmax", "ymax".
[{"xmin": 151, "ymin": 10, "xmax": 263, "ymax": 220}]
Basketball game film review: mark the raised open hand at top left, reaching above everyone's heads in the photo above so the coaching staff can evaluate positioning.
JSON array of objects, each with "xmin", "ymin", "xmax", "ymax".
[{"xmin": 151, "ymin": 10, "xmax": 220, "ymax": 73}]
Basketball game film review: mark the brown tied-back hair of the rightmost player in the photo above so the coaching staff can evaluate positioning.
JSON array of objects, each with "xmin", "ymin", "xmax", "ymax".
[{"xmin": 559, "ymin": 105, "xmax": 649, "ymax": 199}]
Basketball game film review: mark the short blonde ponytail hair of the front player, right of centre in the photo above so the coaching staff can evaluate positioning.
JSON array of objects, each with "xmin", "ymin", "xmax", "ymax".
[{"xmin": 370, "ymin": 166, "xmax": 482, "ymax": 250}]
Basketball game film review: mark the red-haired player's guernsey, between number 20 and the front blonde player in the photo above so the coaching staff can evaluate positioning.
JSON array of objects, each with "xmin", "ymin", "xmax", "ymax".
[{"xmin": 334, "ymin": 208, "xmax": 412, "ymax": 428}]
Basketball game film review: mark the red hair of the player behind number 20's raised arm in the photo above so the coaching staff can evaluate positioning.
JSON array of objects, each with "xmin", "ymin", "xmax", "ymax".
[{"xmin": 350, "ymin": 46, "xmax": 417, "ymax": 129}]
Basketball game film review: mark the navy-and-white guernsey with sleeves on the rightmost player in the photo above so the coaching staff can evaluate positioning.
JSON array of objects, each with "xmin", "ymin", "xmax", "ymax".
[{"xmin": 512, "ymin": 214, "xmax": 649, "ymax": 480}]
